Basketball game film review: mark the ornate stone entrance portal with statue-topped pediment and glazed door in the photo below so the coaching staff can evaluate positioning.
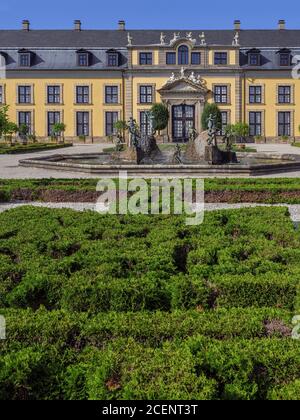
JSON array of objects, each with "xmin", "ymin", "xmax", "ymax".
[{"xmin": 158, "ymin": 68, "xmax": 209, "ymax": 142}]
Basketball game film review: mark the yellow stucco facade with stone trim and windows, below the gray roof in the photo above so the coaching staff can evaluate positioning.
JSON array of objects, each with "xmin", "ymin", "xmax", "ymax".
[{"xmin": 0, "ymin": 30, "xmax": 300, "ymax": 141}]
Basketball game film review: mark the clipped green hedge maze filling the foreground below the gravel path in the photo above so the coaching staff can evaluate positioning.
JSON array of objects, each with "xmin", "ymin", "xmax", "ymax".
[{"xmin": 0, "ymin": 207, "xmax": 300, "ymax": 400}]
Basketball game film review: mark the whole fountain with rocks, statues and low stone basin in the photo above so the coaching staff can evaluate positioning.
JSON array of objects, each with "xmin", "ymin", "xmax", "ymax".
[{"xmin": 19, "ymin": 113, "xmax": 300, "ymax": 177}]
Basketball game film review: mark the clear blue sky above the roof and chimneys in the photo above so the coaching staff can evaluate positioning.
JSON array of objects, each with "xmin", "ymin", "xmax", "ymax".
[{"xmin": 0, "ymin": 0, "xmax": 300, "ymax": 29}]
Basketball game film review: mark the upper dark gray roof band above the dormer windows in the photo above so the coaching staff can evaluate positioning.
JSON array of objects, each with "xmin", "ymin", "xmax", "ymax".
[{"xmin": 0, "ymin": 29, "xmax": 300, "ymax": 49}]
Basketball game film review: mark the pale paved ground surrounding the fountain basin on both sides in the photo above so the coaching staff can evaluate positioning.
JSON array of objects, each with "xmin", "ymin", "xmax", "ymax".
[{"xmin": 0, "ymin": 143, "xmax": 300, "ymax": 179}]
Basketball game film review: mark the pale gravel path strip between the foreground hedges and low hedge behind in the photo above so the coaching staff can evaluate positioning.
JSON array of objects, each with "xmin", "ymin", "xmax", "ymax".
[{"xmin": 0, "ymin": 202, "xmax": 300, "ymax": 223}]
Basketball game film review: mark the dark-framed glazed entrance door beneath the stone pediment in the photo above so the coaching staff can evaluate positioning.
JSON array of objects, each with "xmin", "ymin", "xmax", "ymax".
[{"xmin": 172, "ymin": 105, "xmax": 195, "ymax": 142}]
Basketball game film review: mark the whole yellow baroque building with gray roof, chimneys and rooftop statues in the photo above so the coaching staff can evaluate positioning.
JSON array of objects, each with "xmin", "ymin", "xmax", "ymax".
[{"xmin": 0, "ymin": 20, "xmax": 300, "ymax": 142}]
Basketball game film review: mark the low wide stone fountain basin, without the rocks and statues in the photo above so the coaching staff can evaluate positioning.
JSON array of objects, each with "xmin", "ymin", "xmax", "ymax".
[{"xmin": 19, "ymin": 153, "xmax": 300, "ymax": 177}]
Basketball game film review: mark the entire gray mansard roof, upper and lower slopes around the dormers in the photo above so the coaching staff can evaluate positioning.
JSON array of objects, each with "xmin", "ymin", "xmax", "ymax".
[{"xmin": 0, "ymin": 29, "xmax": 300, "ymax": 70}]
